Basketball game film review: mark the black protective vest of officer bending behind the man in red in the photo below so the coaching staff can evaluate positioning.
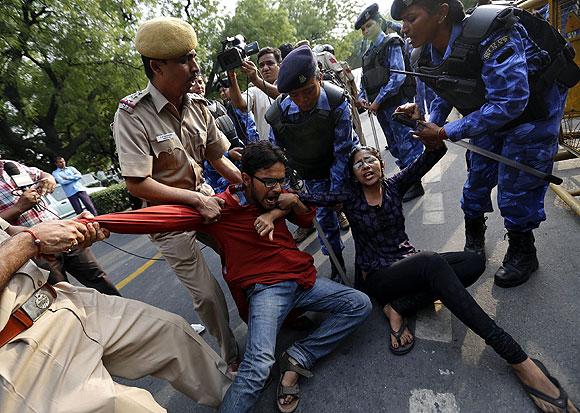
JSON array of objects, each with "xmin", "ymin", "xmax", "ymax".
[{"xmin": 266, "ymin": 82, "xmax": 346, "ymax": 179}]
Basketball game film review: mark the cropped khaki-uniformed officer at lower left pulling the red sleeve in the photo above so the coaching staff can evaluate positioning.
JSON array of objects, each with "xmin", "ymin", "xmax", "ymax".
[{"xmin": 0, "ymin": 218, "xmax": 230, "ymax": 413}]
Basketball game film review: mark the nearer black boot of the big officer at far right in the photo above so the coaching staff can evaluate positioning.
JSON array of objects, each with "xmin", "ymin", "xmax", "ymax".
[{"xmin": 494, "ymin": 231, "xmax": 539, "ymax": 288}]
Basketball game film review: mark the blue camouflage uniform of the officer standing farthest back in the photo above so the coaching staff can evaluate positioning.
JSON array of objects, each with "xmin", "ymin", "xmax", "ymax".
[{"xmin": 359, "ymin": 32, "xmax": 423, "ymax": 169}]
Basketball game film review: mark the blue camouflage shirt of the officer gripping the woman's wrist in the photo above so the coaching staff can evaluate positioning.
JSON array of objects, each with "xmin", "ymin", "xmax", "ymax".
[{"xmin": 424, "ymin": 24, "xmax": 547, "ymax": 141}]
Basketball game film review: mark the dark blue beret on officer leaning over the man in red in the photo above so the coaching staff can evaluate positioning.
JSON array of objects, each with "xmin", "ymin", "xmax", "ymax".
[{"xmin": 276, "ymin": 45, "xmax": 316, "ymax": 93}]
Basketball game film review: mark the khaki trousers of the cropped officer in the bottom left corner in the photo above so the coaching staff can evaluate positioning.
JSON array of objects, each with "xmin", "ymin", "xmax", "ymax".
[{"xmin": 0, "ymin": 283, "xmax": 230, "ymax": 413}]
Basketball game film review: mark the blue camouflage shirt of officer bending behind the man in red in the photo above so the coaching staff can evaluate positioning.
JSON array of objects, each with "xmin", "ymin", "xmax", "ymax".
[{"xmin": 269, "ymin": 88, "xmax": 359, "ymax": 192}]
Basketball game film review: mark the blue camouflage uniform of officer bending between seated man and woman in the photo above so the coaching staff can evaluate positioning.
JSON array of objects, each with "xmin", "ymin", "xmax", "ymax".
[{"xmin": 270, "ymin": 88, "xmax": 359, "ymax": 255}]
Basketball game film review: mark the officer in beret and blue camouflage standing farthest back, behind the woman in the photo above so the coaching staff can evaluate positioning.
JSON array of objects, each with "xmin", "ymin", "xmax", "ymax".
[{"xmin": 354, "ymin": 3, "xmax": 425, "ymax": 201}]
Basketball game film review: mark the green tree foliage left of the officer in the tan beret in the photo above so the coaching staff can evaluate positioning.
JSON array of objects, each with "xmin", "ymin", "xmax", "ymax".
[{"xmin": 0, "ymin": 0, "xmax": 150, "ymax": 169}]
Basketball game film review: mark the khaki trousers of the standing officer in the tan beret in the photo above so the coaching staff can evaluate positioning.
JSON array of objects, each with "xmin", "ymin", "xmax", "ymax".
[{"xmin": 151, "ymin": 232, "xmax": 238, "ymax": 363}]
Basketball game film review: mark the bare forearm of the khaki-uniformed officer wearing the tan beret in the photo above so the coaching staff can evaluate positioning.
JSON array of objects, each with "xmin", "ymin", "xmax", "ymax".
[{"xmin": 125, "ymin": 177, "xmax": 205, "ymax": 207}]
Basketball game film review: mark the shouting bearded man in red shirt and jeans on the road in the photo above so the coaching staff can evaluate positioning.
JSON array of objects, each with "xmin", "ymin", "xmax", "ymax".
[{"xmin": 96, "ymin": 141, "xmax": 371, "ymax": 413}]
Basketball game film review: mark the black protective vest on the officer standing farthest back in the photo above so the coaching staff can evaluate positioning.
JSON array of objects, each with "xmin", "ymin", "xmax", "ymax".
[{"xmin": 362, "ymin": 33, "xmax": 416, "ymax": 106}]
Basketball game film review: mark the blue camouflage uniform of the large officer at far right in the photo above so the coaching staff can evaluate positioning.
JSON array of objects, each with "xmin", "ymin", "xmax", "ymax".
[{"xmin": 430, "ymin": 24, "xmax": 567, "ymax": 232}]
